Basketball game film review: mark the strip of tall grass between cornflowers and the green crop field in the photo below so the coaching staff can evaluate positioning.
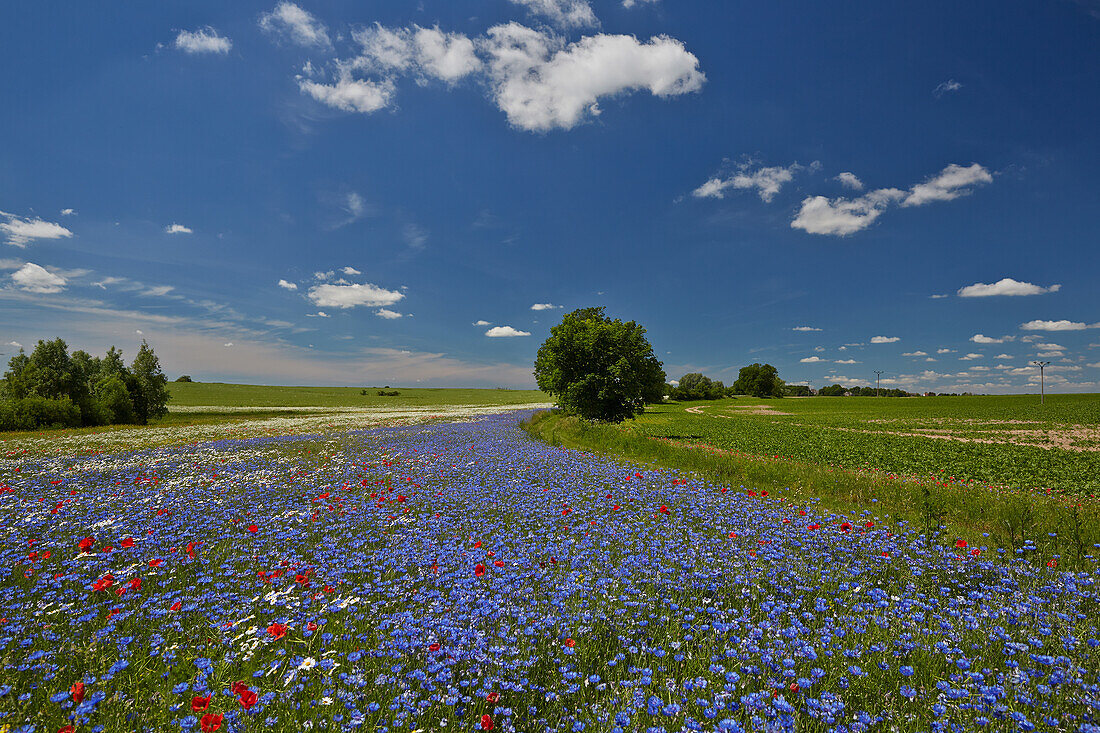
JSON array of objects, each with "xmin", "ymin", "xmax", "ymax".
[{"xmin": 524, "ymin": 412, "xmax": 1100, "ymax": 569}]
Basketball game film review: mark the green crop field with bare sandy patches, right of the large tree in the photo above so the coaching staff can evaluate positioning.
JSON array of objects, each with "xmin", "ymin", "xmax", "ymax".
[{"xmin": 631, "ymin": 395, "xmax": 1100, "ymax": 496}]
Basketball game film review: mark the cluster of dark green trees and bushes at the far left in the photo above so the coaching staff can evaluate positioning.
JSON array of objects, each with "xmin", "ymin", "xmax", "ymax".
[{"xmin": 0, "ymin": 339, "xmax": 169, "ymax": 430}]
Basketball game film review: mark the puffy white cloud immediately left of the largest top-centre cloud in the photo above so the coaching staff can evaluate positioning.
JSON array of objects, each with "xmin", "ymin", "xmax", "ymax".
[{"xmin": 350, "ymin": 24, "xmax": 482, "ymax": 84}]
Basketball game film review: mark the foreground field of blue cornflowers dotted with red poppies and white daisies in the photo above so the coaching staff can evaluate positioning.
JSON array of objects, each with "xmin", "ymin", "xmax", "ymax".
[{"xmin": 0, "ymin": 401, "xmax": 1100, "ymax": 733}]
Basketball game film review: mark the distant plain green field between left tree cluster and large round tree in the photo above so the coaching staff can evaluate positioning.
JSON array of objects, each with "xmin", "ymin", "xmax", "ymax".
[{"xmin": 168, "ymin": 382, "xmax": 550, "ymax": 411}]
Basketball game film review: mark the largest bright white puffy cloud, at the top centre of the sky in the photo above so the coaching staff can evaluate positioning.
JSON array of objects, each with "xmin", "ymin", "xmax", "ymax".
[{"xmin": 481, "ymin": 23, "xmax": 706, "ymax": 132}]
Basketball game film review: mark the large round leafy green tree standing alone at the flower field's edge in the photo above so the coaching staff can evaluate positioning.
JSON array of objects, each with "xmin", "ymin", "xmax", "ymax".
[{"xmin": 535, "ymin": 308, "xmax": 664, "ymax": 423}]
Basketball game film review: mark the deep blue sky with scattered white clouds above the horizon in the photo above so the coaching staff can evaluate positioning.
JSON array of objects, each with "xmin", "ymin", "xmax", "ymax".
[{"xmin": 0, "ymin": 0, "xmax": 1100, "ymax": 393}]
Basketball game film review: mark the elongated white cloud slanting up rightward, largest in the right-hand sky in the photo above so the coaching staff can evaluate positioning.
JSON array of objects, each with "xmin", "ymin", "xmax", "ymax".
[{"xmin": 791, "ymin": 163, "xmax": 993, "ymax": 237}]
